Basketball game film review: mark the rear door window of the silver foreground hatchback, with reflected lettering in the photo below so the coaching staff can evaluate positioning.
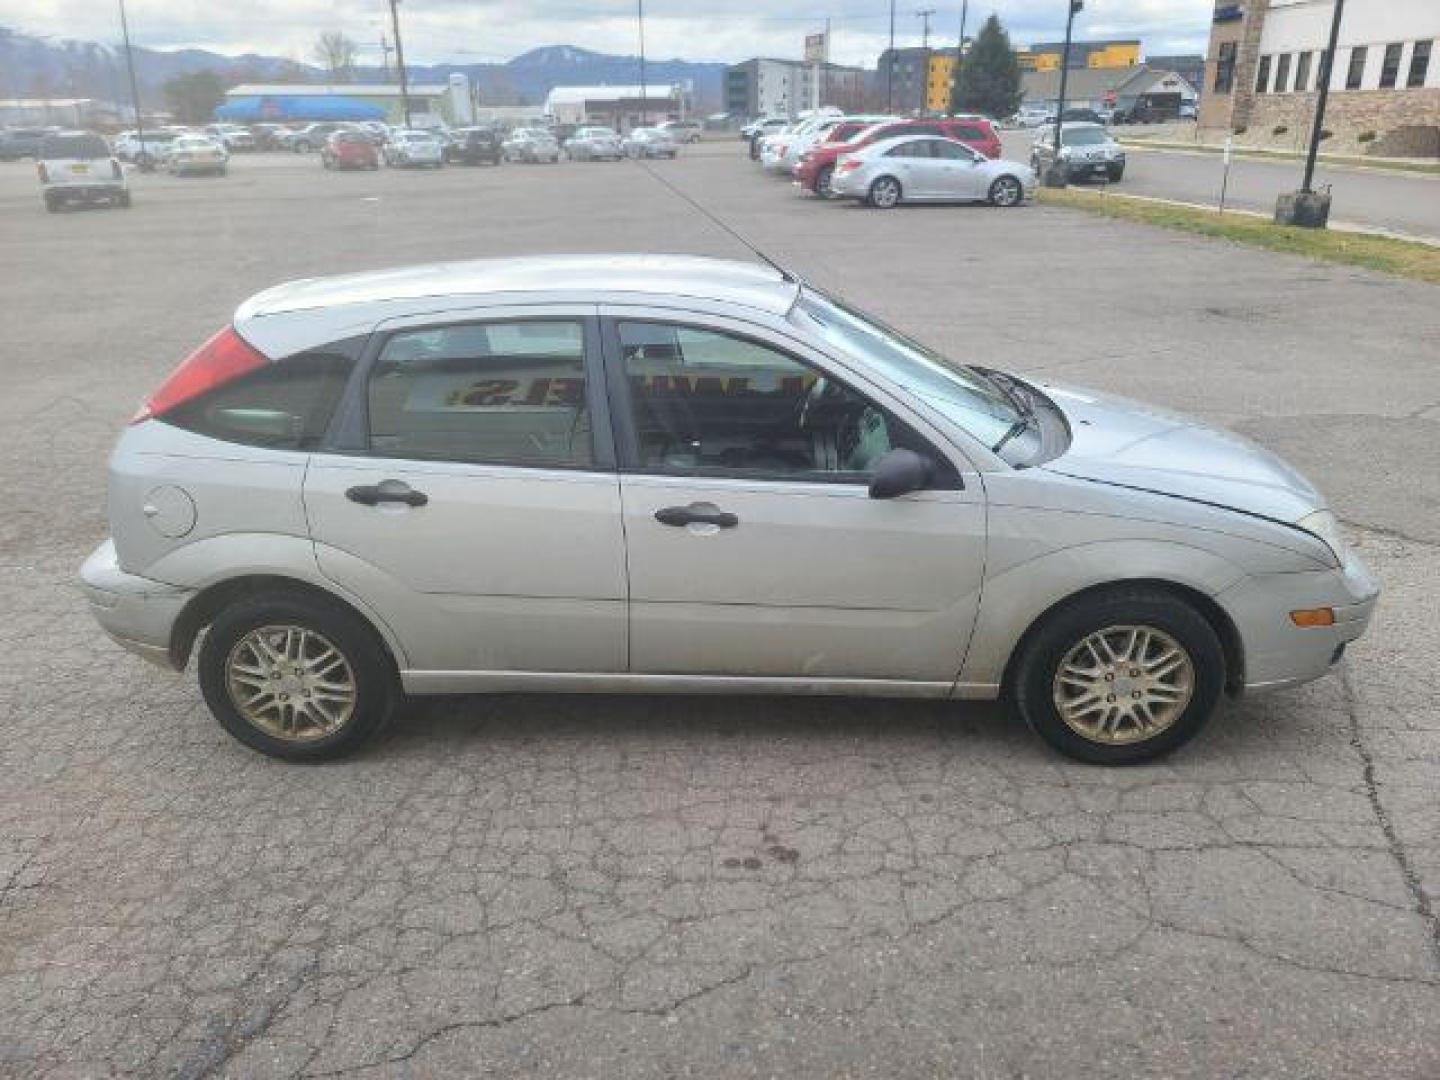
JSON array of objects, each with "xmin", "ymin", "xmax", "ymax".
[{"xmin": 367, "ymin": 320, "xmax": 593, "ymax": 468}]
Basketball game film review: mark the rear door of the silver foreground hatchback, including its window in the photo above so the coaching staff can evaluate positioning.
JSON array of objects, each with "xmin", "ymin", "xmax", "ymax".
[{"xmin": 305, "ymin": 307, "xmax": 626, "ymax": 685}]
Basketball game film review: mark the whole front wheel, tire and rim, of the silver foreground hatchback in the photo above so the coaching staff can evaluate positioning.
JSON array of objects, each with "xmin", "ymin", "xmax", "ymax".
[{"xmin": 1011, "ymin": 588, "xmax": 1225, "ymax": 765}]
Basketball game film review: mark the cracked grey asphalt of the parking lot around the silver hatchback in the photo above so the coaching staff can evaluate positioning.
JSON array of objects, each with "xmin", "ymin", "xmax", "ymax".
[{"xmin": 8, "ymin": 141, "xmax": 1440, "ymax": 1079}]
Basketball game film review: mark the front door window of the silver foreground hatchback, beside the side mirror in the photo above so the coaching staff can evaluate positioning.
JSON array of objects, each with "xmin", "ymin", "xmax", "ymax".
[{"xmin": 619, "ymin": 323, "xmax": 935, "ymax": 482}]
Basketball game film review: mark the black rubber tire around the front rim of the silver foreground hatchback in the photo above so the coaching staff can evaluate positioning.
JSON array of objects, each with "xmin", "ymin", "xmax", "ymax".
[{"xmin": 1009, "ymin": 586, "xmax": 1225, "ymax": 765}]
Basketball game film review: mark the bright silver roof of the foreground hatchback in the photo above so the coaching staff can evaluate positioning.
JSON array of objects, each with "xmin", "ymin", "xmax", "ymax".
[{"xmin": 235, "ymin": 255, "xmax": 799, "ymax": 323}]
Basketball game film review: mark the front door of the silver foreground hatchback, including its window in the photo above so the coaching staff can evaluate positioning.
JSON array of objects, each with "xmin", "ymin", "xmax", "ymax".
[{"xmin": 606, "ymin": 311, "xmax": 985, "ymax": 693}]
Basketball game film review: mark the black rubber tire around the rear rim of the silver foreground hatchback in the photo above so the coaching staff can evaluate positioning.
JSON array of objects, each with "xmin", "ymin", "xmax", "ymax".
[{"xmin": 197, "ymin": 592, "xmax": 402, "ymax": 762}]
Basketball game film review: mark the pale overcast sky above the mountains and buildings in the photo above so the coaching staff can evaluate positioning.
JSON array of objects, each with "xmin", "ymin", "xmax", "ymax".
[{"xmin": 0, "ymin": 0, "xmax": 1214, "ymax": 66}]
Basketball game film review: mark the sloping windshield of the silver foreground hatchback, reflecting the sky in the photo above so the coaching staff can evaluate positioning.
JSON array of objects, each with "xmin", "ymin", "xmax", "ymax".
[{"xmin": 795, "ymin": 289, "xmax": 1022, "ymax": 446}]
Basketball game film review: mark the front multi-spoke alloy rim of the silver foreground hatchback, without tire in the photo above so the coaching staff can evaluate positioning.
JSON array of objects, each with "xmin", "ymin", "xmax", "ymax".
[{"xmin": 1051, "ymin": 625, "xmax": 1195, "ymax": 746}]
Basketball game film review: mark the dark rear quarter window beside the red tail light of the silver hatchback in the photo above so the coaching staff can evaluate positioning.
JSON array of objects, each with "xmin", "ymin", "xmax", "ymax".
[{"xmin": 163, "ymin": 340, "xmax": 363, "ymax": 451}]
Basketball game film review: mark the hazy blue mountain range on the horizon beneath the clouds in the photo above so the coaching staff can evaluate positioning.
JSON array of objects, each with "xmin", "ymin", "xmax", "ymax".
[{"xmin": 0, "ymin": 26, "xmax": 726, "ymax": 107}]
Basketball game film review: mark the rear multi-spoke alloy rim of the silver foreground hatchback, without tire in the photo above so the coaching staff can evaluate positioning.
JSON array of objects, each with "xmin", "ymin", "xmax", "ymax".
[{"xmin": 225, "ymin": 625, "xmax": 357, "ymax": 742}]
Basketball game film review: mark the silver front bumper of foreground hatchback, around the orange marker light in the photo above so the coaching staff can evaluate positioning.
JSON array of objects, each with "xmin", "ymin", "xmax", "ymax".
[{"xmin": 1215, "ymin": 552, "xmax": 1380, "ymax": 690}]
